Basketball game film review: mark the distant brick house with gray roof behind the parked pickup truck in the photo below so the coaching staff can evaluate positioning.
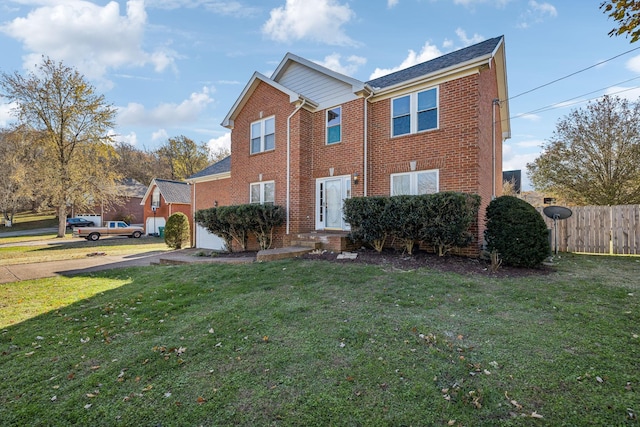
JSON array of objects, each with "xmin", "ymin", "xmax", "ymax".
[{"xmin": 71, "ymin": 178, "xmax": 147, "ymax": 226}]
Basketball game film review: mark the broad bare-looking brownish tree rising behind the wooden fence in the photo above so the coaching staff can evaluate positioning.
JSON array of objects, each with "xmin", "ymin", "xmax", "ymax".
[{"xmin": 527, "ymin": 96, "xmax": 640, "ymax": 205}]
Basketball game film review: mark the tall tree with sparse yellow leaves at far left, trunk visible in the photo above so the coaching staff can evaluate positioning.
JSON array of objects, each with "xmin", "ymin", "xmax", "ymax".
[{"xmin": 0, "ymin": 58, "xmax": 119, "ymax": 237}]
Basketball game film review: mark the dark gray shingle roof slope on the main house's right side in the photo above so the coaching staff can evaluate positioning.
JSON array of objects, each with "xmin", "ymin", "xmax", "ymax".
[{"xmin": 367, "ymin": 36, "xmax": 503, "ymax": 89}]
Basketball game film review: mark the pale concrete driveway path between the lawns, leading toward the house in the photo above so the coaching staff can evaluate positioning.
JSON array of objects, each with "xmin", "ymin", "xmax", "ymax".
[{"xmin": 0, "ymin": 249, "xmax": 255, "ymax": 284}]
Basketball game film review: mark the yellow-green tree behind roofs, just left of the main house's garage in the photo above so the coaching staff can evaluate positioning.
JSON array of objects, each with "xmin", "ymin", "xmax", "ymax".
[{"xmin": 156, "ymin": 135, "xmax": 209, "ymax": 180}]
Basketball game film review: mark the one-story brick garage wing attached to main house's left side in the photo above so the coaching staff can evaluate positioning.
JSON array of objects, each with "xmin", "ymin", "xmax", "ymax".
[{"xmin": 187, "ymin": 156, "xmax": 231, "ymax": 250}]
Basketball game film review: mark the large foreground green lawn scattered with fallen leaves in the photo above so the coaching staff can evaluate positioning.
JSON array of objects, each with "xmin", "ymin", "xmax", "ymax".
[{"xmin": 0, "ymin": 255, "xmax": 640, "ymax": 426}]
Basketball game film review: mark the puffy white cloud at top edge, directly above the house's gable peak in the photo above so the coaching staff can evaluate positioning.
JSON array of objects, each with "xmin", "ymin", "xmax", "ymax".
[{"xmin": 262, "ymin": 0, "xmax": 357, "ymax": 46}]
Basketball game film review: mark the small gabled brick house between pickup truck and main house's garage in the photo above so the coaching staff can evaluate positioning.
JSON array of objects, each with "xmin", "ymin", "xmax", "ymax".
[{"xmin": 140, "ymin": 178, "xmax": 193, "ymax": 234}]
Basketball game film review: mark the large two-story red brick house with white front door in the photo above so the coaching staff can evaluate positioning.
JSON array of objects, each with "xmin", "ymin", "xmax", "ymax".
[{"xmin": 193, "ymin": 37, "xmax": 510, "ymax": 254}]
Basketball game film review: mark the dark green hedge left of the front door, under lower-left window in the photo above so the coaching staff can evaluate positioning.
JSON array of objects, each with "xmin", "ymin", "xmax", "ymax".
[{"xmin": 195, "ymin": 204, "xmax": 285, "ymax": 252}]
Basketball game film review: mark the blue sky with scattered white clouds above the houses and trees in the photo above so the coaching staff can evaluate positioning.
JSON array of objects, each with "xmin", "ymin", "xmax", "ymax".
[{"xmin": 0, "ymin": 0, "xmax": 640, "ymax": 189}]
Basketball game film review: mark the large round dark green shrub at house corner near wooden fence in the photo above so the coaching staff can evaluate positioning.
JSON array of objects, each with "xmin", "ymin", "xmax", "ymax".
[{"xmin": 484, "ymin": 196, "xmax": 550, "ymax": 267}]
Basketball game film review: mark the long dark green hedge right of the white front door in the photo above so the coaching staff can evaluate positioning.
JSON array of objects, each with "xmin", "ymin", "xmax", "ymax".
[{"xmin": 344, "ymin": 192, "xmax": 480, "ymax": 256}]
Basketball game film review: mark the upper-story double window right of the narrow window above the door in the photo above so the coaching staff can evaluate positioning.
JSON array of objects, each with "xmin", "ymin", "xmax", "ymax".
[{"xmin": 391, "ymin": 88, "xmax": 438, "ymax": 136}]
